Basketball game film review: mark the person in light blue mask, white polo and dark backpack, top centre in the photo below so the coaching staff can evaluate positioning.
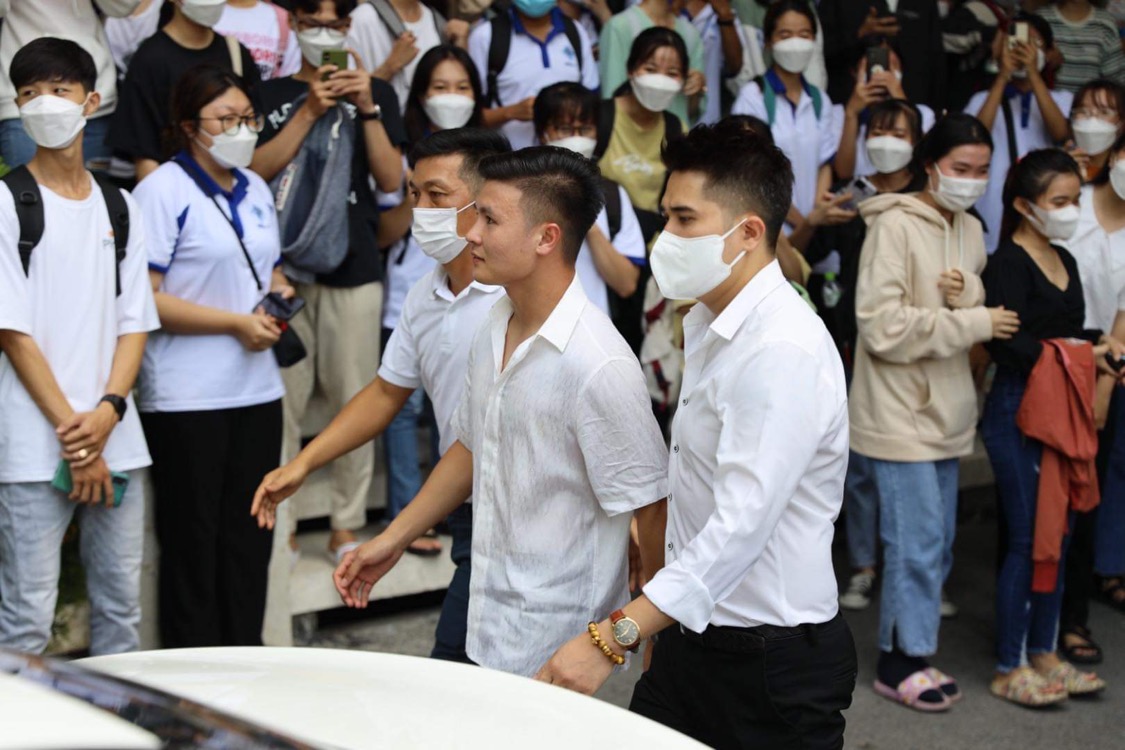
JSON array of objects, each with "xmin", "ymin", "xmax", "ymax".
[{"xmin": 469, "ymin": 0, "xmax": 599, "ymax": 148}]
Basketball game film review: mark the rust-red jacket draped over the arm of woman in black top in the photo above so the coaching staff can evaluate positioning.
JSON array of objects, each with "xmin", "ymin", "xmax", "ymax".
[{"xmin": 1016, "ymin": 338, "xmax": 1100, "ymax": 594}]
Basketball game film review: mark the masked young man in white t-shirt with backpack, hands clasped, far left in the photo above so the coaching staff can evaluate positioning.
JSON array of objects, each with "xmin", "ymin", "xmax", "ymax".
[{"xmin": 0, "ymin": 37, "xmax": 160, "ymax": 654}]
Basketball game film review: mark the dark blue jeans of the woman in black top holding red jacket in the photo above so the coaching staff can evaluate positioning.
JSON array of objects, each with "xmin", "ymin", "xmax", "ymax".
[{"xmin": 981, "ymin": 369, "xmax": 1073, "ymax": 674}]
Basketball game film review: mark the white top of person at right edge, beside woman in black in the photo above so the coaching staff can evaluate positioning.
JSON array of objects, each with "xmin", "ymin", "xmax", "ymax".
[{"xmin": 1061, "ymin": 184, "xmax": 1125, "ymax": 333}]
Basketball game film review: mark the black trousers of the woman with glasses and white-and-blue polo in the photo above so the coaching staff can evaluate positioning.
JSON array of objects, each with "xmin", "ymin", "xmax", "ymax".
[{"xmin": 141, "ymin": 400, "xmax": 281, "ymax": 649}]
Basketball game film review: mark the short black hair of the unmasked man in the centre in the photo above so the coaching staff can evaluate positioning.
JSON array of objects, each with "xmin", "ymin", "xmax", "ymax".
[{"xmin": 480, "ymin": 146, "xmax": 605, "ymax": 265}]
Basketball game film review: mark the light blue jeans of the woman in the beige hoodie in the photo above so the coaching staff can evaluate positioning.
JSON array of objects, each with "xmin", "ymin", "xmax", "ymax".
[{"xmin": 871, "ymin": 459, "xmax": 957, "ymax": 657}]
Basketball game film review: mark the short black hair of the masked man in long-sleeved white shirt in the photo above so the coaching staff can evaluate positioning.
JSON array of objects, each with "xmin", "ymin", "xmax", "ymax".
[{"xmin": 664, "ymin": 119, "xmax": 793, "ymax": 249}]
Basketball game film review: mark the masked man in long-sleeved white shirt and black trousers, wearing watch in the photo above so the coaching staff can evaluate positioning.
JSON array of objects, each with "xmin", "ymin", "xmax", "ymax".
[{"xmin": 539, "ymin": 123, "xmax": 856, "ymax": 748}]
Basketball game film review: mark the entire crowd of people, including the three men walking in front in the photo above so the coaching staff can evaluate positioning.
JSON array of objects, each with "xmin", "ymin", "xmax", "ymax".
[{"xmin": 0, "ymin": 0, "xmax": 1125, "ymax": 747}]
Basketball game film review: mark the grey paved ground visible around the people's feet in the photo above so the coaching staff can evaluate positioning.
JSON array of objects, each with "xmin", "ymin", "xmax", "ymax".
[{"xmin": 312, "ymin": 491, "xmax": 1125, "ymax": 750}]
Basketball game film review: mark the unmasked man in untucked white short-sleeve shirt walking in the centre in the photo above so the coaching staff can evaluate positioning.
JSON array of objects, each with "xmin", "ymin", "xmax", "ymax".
[{"xmin": 335, "ymin": 146, "xmax": 667, "ymax": 676}]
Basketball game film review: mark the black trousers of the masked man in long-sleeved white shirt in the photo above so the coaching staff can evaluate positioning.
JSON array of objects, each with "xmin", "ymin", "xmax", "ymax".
[{"xmin": 629, "ymin": 614, "xmax": 856, "ymax": 750}]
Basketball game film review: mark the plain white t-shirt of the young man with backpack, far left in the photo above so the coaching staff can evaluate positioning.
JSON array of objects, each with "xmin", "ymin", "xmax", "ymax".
[{"xmin": 0, "ymin": 177, "xmax": 160, "ymax": 482}]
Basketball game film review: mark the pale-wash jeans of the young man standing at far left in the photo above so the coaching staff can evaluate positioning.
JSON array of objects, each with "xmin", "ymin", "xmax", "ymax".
[{"xmin": 0, "ymin": 471, "xmax": 144, "ymax": 656}]
